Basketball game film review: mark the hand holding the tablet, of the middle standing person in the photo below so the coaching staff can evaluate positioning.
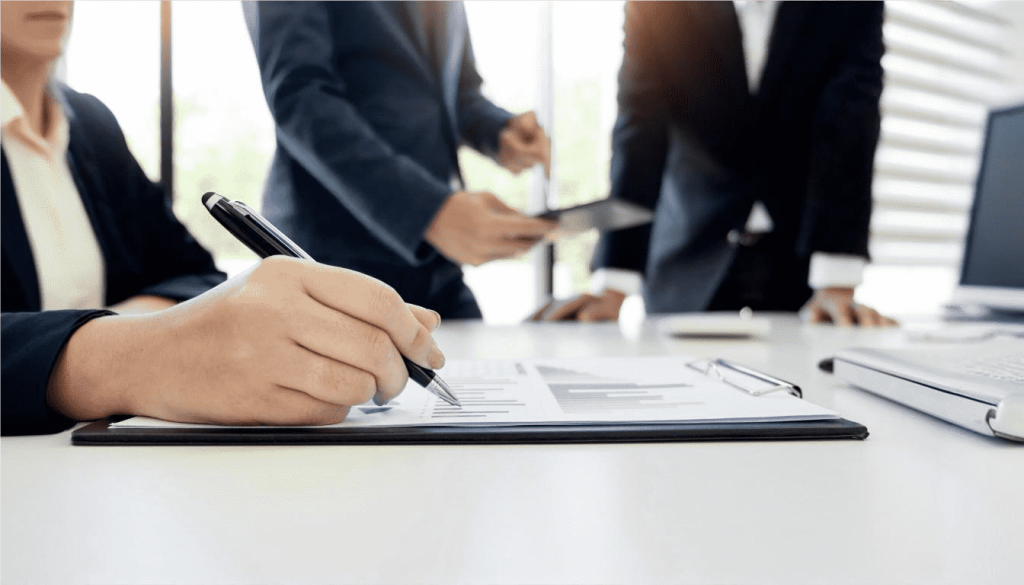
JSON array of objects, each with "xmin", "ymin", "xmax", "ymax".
[{"xmin": 424, "ymin": 191, "xmax": 558, "ymax": 266}]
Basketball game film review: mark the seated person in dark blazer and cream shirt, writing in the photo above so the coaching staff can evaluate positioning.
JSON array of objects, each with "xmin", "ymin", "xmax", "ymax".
[{"xmin": 0, "ymin": 0, "xmax": 443, "ymax": 435}]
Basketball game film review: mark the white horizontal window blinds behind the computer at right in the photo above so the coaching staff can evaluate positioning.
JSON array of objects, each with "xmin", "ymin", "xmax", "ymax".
[{"xmin": 870, "ymin": 1, "xmax": 1011, "ymax": 267}]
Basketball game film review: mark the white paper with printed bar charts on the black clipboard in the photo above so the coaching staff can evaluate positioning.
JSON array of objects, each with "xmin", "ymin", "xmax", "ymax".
[{"xmin": 112, "ymin": 356, "xmax": 839, "ymax": 428}]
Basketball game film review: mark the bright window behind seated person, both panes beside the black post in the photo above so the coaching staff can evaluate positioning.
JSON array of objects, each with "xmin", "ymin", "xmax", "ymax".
[{"xmin": 65, "ymin": 0, "xmax": 274, "ymax": 273}]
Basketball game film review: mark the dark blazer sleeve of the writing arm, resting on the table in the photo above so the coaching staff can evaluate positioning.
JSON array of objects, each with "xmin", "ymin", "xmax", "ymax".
[{"xmin": 0, "ymin": 310, "xmax": 113, "ymax": 435}]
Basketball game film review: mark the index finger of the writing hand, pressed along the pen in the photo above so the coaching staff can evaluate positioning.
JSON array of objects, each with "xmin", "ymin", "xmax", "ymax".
[{"xmin": 299, "ymin": 261, "xmax": 435, "ymax": 368}]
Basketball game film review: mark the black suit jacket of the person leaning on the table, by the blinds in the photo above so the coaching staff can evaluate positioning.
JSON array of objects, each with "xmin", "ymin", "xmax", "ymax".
[{"xmin": 593, "ymin": 2, "xmax": 884, "ymax": 312}]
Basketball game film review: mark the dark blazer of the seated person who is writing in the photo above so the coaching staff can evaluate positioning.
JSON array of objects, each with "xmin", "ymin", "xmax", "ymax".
[{"xmin": 0, "ymin": 85, "xmax": 224, "ymax": 434}]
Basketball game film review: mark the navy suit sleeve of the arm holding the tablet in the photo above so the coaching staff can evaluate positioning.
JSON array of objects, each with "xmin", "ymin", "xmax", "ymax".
[{"xmin": 244, "ymin": 1, "xmax": 452, "ymax": 263}]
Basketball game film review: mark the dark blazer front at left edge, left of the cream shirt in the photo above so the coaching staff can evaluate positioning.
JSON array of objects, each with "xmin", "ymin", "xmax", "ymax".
[{"xmin": 0, "ymin": 150, "xmax": 42, "ymax": 310}]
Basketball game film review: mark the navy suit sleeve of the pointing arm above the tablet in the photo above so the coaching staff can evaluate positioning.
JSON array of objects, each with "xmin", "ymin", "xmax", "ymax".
[{"xmin": 456, "ymin": 4, "xmax": 513, "ymax": 158}]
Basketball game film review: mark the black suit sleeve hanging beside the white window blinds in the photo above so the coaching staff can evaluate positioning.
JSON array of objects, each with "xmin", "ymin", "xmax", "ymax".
[{"xmin": 798, "ymin": 2, "xmax": 885, "ymax": 257}]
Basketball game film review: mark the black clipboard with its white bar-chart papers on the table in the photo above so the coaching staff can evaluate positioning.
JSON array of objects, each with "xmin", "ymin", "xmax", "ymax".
[{"xmin": 86, "ymin": 356, "xmax": 867, "ymax": 445}]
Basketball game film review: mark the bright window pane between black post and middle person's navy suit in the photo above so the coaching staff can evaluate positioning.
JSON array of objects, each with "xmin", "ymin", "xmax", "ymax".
[{"xmin": 171, "ymin": 2, "xmax": 274, "ymax": 274}]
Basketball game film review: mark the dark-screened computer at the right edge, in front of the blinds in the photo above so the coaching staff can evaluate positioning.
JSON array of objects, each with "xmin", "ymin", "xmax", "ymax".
[{"xmin": 949, "ymin": 103, "xmax": 1024, "ymax": 321}]
